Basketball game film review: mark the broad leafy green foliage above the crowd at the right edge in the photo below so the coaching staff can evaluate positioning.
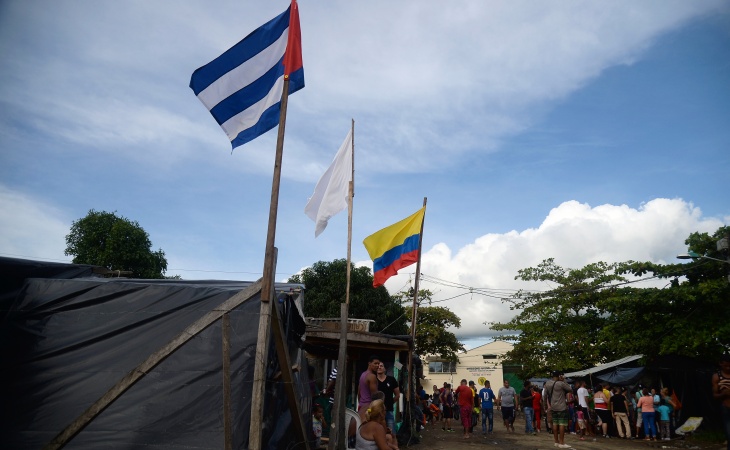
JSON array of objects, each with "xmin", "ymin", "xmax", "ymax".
[{"xmin": 490, "ymin": 227, "xmax": 730, "ymax": 377}]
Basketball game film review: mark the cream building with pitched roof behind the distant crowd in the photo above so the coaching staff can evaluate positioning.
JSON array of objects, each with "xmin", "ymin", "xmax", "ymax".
[{"xmin": 421, "ymin": 341, "xmax": 513, "ymax": 394}]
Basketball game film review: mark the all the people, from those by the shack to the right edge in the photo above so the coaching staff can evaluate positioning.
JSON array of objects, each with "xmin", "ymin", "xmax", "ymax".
[{"xmin": 314, "ymin": 355, "xmax": 730, "ymax": 450}]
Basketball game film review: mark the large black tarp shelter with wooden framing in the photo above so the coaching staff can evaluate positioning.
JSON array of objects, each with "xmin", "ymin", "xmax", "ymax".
[{"xmin": 0, "ymin": 258, "xmax": 311, "ymax": 449}]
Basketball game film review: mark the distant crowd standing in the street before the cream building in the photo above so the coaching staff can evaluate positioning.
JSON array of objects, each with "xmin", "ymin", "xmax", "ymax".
[{"xmin": 406, "ymin": 371, "xmax": 681, "ymax": 448}]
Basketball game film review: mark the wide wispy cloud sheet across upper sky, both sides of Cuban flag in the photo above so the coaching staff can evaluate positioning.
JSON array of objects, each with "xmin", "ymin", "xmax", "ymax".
[{"xmin": 0, "ymin": 0, "xmax": 723, "ymax": 180}]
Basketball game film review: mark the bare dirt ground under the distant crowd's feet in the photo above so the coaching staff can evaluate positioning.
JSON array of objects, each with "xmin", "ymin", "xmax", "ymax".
[{"xmin": 401, "ymin": 413, "xmax": 726, "ymax": 450}]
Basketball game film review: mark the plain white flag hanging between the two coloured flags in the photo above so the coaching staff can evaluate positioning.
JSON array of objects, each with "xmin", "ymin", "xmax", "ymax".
[{"xmin": 304, "ymin": 130, "xmax": 352, "ymax": 237}]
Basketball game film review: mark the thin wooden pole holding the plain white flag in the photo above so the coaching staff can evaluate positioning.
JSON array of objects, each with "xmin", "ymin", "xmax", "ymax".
[{"xmin": 328, "ymin": 119, "xmax": 355, "ymax": 450}]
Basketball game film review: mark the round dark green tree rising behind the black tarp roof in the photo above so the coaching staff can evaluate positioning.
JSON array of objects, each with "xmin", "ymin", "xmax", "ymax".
[{"xmin": 65, "ymin": 209, "xmax": 167, "ymax": 278}]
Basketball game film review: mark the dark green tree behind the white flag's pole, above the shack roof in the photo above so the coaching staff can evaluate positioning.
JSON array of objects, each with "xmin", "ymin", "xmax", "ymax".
[{"xmin": 289, "ymin": 259, "xmax": 410, "ymax": 335}]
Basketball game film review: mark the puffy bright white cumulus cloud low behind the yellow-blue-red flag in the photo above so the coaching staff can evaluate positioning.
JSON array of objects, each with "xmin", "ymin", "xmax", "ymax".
[{"xmin": 378, "ymin": 198, "xmax": 728, "ymax": 339}]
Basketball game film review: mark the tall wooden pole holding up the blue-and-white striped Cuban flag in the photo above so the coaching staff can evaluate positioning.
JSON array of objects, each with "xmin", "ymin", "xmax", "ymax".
[{"xmin": 248, "ymin": 77, "xmax": 294, "ymax": 450}]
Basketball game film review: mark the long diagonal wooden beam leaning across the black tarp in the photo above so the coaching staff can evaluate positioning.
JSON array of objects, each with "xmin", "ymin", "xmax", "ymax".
[{"xmin": 43, "ymin": 279, "xmax": 261, "ymax": 450}]
